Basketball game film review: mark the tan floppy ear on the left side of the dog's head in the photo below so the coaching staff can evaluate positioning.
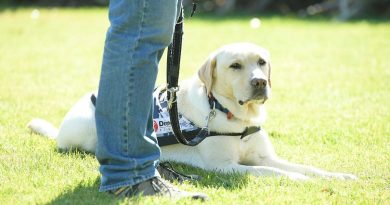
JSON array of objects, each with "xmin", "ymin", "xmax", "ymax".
[{"xmin": 198, "ymin": 54, "xmax": 217, "ymax": 95}]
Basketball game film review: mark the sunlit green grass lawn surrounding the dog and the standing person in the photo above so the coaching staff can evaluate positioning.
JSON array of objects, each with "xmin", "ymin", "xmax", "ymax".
[{"xmin": 0, "ymin": 8, "xmax": 390, "ymax": 204}]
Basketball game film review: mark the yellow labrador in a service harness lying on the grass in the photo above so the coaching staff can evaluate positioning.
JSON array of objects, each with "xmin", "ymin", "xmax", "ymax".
[{"xmin": 28, "ymin": 43, "xmax": 356, "ymax": 179}]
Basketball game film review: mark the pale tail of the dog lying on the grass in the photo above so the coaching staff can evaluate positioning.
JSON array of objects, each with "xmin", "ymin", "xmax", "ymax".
[{"xmin": 27, "ymin": 119, "xmax": 58, "ymax": 139}]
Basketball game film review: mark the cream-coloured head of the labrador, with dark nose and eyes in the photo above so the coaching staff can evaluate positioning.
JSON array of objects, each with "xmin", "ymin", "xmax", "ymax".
[{"xmin": 198, "ymin": 43, "xmax": 271, "ymax": 106}]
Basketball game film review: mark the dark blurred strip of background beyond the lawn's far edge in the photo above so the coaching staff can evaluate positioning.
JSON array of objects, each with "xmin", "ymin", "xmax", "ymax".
[{"xmin": 0, "ymin": 0, "xmax": 390, "ymax": 20}]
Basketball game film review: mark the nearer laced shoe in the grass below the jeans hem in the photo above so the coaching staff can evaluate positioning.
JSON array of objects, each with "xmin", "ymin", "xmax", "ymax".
[{"xmin": 108, "ymin": 177, "xmax": 207, "ymax": 201}]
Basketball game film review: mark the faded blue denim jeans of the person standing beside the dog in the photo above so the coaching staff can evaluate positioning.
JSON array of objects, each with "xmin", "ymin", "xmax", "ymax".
[{"xmin": 95, "ymin": 0, "xmax": 181, "ymax": 191}]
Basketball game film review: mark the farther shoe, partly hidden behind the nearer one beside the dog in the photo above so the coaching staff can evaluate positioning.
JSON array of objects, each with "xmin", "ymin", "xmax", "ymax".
[{"xmin": 157, "ymin": 162, "xmax": 200, "ymax": 184}]
